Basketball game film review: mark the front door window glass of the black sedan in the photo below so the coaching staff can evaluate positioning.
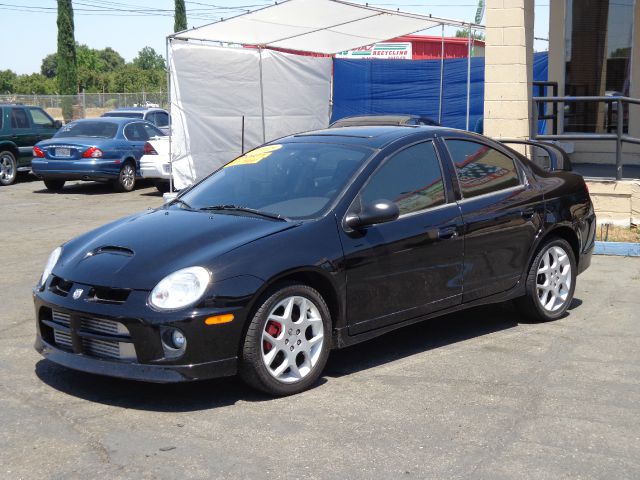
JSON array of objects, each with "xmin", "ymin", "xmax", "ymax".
[{"xmin": 360, "ymin": 141, "xmax": 446, "ymax": 215}]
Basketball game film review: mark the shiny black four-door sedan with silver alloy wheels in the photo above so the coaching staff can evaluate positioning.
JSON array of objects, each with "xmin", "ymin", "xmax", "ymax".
[{"xmin": 34, "ymin": 127, "xmax": 595, "ymax": 395}]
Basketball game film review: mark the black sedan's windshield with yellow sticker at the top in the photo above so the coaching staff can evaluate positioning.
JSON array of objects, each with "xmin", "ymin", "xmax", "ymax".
[{"xmin": 180, "ymin": 143, "xmax": 373, "ymax": 219}]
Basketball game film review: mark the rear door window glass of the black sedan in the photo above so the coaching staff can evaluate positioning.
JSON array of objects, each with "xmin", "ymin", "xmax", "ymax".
[{"xmin": 446, "ymin": 139, "xmax": 520, "ymax": 198}]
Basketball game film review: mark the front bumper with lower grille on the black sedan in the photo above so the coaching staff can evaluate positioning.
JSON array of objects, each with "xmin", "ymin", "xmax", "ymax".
[{"xmin": 34, "ymin": 275, "xmax": 252, "ymax": 383}]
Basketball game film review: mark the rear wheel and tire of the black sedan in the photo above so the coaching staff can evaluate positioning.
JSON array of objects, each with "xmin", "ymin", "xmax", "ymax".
[{"xmin": 516, "ymin": 238, "xmax": 577, "ymax": 322}]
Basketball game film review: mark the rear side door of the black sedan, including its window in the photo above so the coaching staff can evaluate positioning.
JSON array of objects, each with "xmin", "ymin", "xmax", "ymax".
[{"xmin": 444, "ymin": 137, "xmax": 544, "ymax": 303}]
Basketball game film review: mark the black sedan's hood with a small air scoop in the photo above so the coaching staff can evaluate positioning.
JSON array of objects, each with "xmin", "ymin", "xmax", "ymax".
[{"xmin": 54, "ymin": 209, "xmax": 296, "ymax": 290}]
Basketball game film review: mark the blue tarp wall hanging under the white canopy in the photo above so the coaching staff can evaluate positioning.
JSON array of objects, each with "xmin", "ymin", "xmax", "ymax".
[{"xmin": 331, "ymin": 52, "xmax": 548, "ymax": 130}]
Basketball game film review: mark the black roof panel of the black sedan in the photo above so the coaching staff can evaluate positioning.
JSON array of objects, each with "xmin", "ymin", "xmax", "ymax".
[{"xmin": 282, "ymin": 125, "xmax": 460, "ymax": 148}]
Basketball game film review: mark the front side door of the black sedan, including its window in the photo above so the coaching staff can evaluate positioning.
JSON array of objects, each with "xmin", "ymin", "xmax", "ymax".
[{"xmin": 340, "ymin": 140, "xmax": 463, "ymax": 334}]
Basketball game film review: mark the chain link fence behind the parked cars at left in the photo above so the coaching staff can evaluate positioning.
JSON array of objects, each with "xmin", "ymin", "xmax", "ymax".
[{"xmin": 0, "ymin": 92, "xmax": 169, "ymax": 121}]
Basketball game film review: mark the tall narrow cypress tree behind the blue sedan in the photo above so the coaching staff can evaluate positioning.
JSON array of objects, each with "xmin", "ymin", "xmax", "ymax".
[{"xmin": 57, "ymin": 0, "xmax": 78, "ymax": 122}]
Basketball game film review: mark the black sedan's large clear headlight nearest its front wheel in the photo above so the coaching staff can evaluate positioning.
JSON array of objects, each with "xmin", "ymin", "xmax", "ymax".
[{"xmin": 149, "ymin": 267, "xmax": 211, "ymax": 310}]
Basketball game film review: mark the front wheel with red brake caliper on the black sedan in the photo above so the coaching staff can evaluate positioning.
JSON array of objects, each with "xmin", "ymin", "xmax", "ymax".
[{"xmin": 240, "ymin": 284, "xmax": 331, "ymax": 396}]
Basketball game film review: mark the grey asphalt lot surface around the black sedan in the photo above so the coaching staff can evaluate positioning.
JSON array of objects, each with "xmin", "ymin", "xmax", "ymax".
[{"xmin": 0, "ymin": 181, "xmax": 640, "ymax": 480}]
